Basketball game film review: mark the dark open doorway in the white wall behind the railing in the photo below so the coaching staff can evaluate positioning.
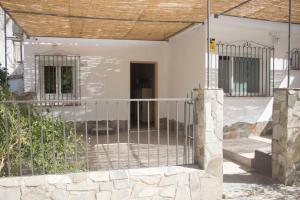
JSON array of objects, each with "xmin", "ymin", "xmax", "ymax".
[{"xmin": 130, "ymin": 63, "xmax": 155, "ymax": 128}]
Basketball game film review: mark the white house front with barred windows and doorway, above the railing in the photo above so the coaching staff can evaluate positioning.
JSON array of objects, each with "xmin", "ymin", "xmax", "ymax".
[{"xmin": 1, "ymin": 3, "xmax": 300, "ymax": 137}]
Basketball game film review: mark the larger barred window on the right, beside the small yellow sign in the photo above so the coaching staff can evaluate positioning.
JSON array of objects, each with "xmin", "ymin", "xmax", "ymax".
[{"xmin": 217, "ymin": 42, "xmax": 274, "ymax": 97}]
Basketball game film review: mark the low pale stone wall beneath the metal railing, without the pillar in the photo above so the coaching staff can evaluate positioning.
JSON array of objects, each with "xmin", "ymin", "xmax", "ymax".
[{"xmin": 0, "ymin": 166, "xmax": 222, "ymax": 200}]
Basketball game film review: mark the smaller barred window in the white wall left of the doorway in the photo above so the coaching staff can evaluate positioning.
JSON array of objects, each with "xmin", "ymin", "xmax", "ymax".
[{"xmin": 35, "ymin": 55, "xmax": 80, "ymax": 100}]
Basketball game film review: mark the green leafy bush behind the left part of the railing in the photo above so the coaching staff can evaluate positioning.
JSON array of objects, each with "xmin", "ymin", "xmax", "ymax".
[{"xmin": 0, "ymin": 68, "xmax": 84, "ymax": 176}]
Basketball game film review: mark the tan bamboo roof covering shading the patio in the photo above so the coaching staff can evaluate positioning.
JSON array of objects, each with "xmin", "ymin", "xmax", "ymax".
[{"xmin": 0, "ymin": 0, "xmax": 300, "ymax": 40}]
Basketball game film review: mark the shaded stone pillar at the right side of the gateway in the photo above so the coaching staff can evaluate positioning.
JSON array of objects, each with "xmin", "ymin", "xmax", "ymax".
[{"xmin": 272, "ymin": 89, "xmax": 300, "ymax": 185}]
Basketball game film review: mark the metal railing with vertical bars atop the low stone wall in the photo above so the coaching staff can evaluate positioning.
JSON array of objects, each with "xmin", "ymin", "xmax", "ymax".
[{"xmin": 0, "ymin": 98, "xmax": 194, "ymax": 176}]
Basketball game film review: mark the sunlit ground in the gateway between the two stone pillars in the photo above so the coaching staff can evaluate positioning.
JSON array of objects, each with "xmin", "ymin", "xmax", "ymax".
[{"xmin": 223, "ymin": 161, "xmax": 300, "ymax": 200}]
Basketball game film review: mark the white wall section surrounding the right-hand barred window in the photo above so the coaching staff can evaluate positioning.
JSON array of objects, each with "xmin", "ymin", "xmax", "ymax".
[{"xmin": 211, "ymin": 17, "xmax": 300, "ymax": 125}]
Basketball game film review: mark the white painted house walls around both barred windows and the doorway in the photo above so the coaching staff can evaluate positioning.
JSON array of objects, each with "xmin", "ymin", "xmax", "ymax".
[{"xmin": 11, "ymin": 16, "xmax": 300, "ymax": 125}]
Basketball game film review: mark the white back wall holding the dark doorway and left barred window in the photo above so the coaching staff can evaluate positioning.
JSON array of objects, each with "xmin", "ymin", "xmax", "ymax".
[{"xmin": 24, "ymin": 38, "xmax": 168, "ymax": 99}]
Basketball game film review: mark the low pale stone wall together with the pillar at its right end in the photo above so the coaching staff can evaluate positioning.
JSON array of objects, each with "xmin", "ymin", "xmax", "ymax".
[{"xmin": 0, "ymin": 89, "xmax": 223, "ymax": 200}]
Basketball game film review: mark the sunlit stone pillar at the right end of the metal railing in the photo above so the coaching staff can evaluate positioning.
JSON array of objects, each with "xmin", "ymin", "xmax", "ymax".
[{"xmin": 193, "ymin": 89, "xmax": 224, "ymax": 177}]
